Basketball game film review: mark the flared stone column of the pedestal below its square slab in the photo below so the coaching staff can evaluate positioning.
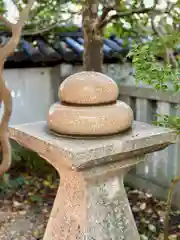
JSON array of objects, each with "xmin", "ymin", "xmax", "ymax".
[{"xmin": 44, "ymin": 159, "xmax": 140, "ymax": 240}]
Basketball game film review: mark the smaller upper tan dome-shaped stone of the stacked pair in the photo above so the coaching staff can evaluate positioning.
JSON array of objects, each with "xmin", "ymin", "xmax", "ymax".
[{"xmin": 58, "ymin": 71, "xmax": 119, "ymax": 105}]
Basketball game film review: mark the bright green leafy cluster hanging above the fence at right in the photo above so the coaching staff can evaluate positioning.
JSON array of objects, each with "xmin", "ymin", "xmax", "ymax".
[{"xmin": 128, "ymin": 38, "xmax": 180, "ymax": 92}]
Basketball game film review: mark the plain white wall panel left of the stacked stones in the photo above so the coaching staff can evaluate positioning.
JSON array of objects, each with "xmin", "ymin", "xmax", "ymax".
[{"xmin": 1, "ymin": 68, "xmax": 54, "ymax": 124}]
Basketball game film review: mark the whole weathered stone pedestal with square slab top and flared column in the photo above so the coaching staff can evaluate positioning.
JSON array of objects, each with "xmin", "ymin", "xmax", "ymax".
[{"xmin": 10, "ymin": 122, "xmax": 177, "ymax": 240}]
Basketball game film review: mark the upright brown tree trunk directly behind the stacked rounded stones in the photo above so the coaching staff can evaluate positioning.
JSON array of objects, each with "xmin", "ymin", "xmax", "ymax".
[{"xmin": 83, "ymin": 0, "xmax": 103, "ymax": 72}]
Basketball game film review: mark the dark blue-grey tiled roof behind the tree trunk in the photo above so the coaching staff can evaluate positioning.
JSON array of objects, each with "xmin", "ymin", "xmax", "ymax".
[{"xmin": 0, "ymin": 28, "xmax": 179, "ymax": 68}]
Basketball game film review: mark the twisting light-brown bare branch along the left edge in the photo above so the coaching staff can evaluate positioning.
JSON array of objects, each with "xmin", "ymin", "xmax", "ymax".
[{"xmin": 0, "ymin": 0, "xmax": 34, "ymax": 176}]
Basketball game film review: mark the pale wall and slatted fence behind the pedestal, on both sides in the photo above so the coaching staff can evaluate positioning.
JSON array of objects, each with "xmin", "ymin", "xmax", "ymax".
[{"xmin": 4, "ymin": 63, "xmax": 180, "ymax": 206}]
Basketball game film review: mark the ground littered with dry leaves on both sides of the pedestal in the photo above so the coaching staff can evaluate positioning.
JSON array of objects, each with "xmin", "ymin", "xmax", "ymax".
[{"xmin": 0, "ymin": 175, "xmax": 180, "ymax": 240}]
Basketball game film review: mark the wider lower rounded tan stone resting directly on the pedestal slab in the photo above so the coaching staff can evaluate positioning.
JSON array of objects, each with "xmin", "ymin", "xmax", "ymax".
[{"xmin": 47, "ymin": 101, "xmax": 133, "ymax": 136}]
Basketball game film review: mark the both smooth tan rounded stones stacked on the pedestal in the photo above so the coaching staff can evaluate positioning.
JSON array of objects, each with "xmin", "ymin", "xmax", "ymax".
[{"xmin": 47, "ymin": 71, "xmax": 133, "ymax": 136}]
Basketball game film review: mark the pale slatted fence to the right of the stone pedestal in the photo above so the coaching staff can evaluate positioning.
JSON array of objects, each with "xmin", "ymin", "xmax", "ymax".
[{"xmin": 116, "ymin": 77, "xmax": 180, "ymax": 201}]
